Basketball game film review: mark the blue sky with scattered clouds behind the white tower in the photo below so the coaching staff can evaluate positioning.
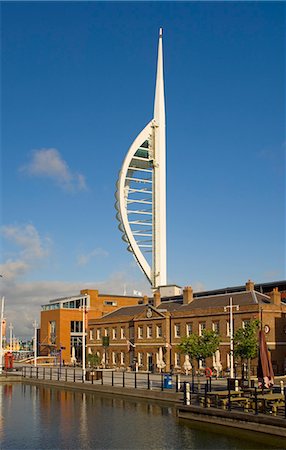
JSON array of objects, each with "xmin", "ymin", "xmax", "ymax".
[{"xmin": 1, "ymin": 2, "xmax": 285, "ymax": 336}]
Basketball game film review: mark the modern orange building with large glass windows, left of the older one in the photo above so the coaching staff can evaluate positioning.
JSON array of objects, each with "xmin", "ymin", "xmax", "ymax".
[{"xmin": 40, "ymin": 289, "xmax": 142, "ymax": 364}]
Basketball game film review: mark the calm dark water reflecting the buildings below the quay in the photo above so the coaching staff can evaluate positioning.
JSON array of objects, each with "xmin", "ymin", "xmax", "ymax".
[{"xmin": 0, "ymin": 383, "xmax": 282, "ymax": 450}]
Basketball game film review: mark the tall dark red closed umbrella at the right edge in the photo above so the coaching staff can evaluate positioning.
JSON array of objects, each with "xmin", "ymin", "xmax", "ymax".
[{"xmin": 257, "ymin": 330, "xmax": 274, "ymax": 388}]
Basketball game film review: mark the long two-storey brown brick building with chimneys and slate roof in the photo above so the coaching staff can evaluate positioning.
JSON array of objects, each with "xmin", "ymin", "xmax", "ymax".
[{"xmin": 87, "ymin": 281, "xmax": 286, "ymax": 374}]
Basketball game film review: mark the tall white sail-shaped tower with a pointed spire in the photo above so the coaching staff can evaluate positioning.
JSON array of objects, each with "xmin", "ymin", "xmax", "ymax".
[{"xmin": 115, "ymin": 28, "xmax": 167, "ymax": 288}]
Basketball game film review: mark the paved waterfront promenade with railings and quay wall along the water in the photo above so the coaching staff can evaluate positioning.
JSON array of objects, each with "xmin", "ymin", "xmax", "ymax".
[{"xmin": 1, "ymin": 366, "xmax": 286, "ymax": 443}]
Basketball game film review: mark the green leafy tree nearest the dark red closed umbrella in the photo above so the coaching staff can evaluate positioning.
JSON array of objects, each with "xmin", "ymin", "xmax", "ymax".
[{"xmin": 233, "ymin": 319, "xmax": 260, "ymax": 383}]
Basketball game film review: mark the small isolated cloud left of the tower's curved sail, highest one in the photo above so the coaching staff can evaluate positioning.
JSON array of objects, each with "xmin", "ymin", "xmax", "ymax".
[{"xmin": 20, "ymin": 148, "xmax": 87, "ymax": 191}]
